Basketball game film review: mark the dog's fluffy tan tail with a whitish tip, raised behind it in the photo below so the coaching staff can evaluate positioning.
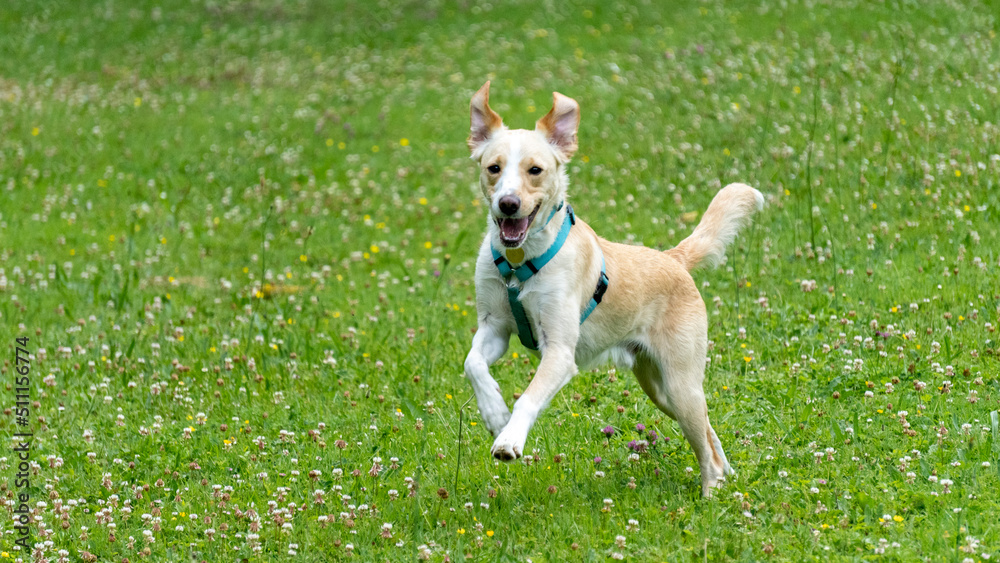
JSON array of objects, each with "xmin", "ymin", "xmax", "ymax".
[{"xmin": 666, "ymin": 184, "xmax": 764, "ymax": 271}]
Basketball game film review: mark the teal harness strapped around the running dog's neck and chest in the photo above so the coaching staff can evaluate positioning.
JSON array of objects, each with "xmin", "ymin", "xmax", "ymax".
[{"xmin": 490, "ymin": 204, "xmax": 608, "ymax": 351}]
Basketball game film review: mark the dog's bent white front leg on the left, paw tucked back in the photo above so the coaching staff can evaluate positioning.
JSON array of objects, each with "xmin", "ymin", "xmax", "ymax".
[{"xmin": 465, "ymin": 322, "xmax": 510, "ymax": 436}]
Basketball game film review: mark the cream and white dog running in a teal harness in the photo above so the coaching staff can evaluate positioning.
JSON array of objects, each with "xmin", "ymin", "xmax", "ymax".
[{"xmin": 465, "ymin": 82, "xmax": 764, "ymax": 496}]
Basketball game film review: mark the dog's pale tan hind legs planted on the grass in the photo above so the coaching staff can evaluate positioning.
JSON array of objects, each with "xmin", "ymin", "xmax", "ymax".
[{"xmin": 633, "ymin": 322, "xmax": 732, "ymax": 496}]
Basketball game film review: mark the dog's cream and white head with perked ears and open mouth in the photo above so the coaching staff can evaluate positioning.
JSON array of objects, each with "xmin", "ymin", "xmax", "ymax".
[{"xmin": 469, "ymin": 82, "xmax": 580, "ymax": 247}]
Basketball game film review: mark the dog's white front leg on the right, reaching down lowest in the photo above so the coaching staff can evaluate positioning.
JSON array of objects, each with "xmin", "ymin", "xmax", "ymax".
[{"xmin": 492, "ymin": 345, "xmax": 576, "ymax": 461}]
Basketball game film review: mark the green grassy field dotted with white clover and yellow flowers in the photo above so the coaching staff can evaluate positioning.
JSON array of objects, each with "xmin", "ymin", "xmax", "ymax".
[{"xmin": 0, "ymin": 0, "xmax": 1000, "ymax": 562}]
